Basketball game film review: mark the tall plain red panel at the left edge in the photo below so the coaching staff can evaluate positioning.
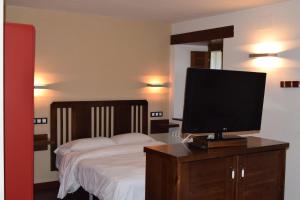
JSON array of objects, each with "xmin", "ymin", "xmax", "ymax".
[{"xmin": 4, "ymin": 23, "xmax": 35, "ymax": 200}]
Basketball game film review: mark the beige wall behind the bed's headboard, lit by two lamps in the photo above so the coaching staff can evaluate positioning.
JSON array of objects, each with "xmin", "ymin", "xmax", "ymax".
[{"xmin": 6, "ymin": 6, "xmax": 171, "ymax": 183}]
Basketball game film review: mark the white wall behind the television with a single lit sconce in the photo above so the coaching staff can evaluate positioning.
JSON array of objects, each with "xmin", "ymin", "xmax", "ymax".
[{"xmin": 171, "ymin": 0, "xmax": 300, "ymax": 200}]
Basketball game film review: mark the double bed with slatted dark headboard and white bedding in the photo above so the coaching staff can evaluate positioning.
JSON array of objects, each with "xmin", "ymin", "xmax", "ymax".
[{"xmin": 50, "ymin": 100, "xmax": 162, "ymax": 200}]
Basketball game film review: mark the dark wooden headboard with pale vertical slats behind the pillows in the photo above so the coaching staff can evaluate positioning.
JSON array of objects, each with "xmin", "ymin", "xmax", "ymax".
[{"xmin": 50, "ymin": 100, "xmax": 148, "ymax": 170}]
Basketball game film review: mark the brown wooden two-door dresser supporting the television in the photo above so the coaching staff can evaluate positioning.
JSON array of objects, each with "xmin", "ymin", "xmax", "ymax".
[{"xmin": 144, "ymin": 137, "xmax": 289, "ymax": 200}]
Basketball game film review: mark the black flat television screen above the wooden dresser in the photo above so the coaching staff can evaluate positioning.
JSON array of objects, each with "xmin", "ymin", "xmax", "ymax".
[{"xmin": 182, "ymin": 68, "xmax": 266, "ymax": 133}]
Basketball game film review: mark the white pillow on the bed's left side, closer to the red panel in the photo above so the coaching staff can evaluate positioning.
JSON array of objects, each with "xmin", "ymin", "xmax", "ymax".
[{"xmin": 54, "ymin": 137, "xmax": 116, "ymax": 154}]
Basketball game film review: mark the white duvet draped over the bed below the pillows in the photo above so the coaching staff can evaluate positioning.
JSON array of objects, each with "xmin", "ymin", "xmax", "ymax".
[{"xmin": 57, "ymin": 142, "xmax": 163, "ymax": 200}]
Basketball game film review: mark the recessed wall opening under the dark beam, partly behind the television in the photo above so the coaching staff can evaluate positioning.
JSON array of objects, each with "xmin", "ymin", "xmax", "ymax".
[{"xmin": 171, "ymin": 39, "xmax": 223, "ymax": 119}]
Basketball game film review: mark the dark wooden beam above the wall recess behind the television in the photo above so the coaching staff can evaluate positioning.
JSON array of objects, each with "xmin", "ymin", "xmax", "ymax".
[{"xmin": 171, "ymin": 25, "xmax": 234, "ymax": 45}]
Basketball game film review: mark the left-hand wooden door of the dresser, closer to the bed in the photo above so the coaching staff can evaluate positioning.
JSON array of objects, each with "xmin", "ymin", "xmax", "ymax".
[{"xmin": 183, "ymin": 157, "xmax": 237, "ymax": 200}]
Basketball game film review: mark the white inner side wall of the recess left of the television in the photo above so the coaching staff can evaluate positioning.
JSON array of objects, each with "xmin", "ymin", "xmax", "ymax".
[{"xmin": 170, "ymin": 45, "xmax": 208, "ymax": 118}]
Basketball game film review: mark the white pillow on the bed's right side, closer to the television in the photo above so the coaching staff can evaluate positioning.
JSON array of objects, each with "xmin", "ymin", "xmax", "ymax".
[{"xmin": 111, "ymin": 133, "xmax": 156, "ymax": 144}]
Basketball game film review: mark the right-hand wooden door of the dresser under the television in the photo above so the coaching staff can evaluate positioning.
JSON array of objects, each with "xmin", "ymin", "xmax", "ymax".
[{"xmin": 238, "ymin": 151, "xmax": 285, "ymax": 200}]
